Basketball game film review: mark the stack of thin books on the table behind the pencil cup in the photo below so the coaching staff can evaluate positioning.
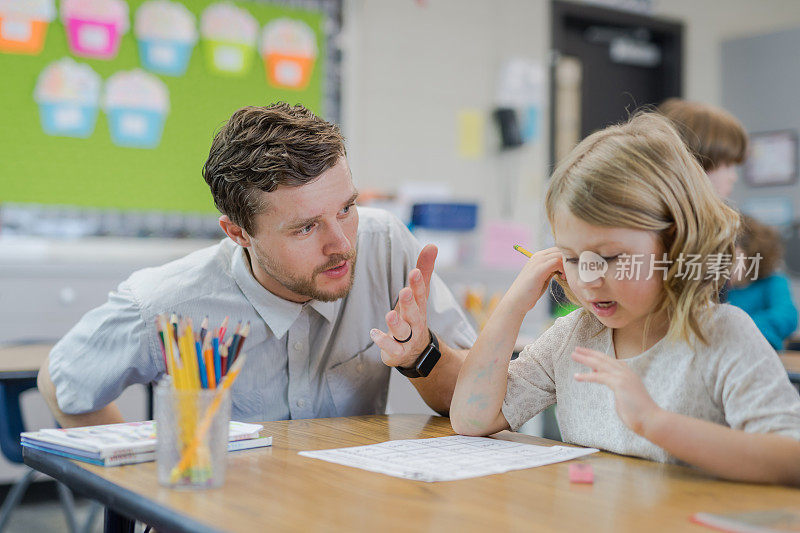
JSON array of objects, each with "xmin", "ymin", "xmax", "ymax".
[{"xmin": 20, "ymin": 420, "xmax": 272, "ymax": 466}]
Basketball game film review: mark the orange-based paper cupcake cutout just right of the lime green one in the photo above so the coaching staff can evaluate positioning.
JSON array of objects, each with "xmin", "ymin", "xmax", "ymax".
[{"xmin": 261, "ymin": 18, "xmax": 317, "ymax": 90}]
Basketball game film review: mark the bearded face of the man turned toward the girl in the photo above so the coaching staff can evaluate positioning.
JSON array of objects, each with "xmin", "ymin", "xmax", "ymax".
[{"xmin": 249, "ymin": 157, "xmax": 358, "ymax": 302}]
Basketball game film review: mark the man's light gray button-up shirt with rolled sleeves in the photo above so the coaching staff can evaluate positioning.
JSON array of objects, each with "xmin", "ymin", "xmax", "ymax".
[{"xmin": 49, "ymin": 207, "xmax": 476, "ymax": 421}]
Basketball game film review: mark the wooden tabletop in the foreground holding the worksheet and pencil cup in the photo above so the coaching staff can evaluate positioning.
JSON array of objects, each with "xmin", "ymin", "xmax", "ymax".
[{"xmin": 25, "ymin": 415, "xmax": 800, "ymax": 533}]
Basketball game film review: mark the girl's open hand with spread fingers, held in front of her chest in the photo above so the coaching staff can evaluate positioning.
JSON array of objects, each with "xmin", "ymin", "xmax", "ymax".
[{"xmin": 572, "ymin": 347, "xmax": 661, "ymax": 436}]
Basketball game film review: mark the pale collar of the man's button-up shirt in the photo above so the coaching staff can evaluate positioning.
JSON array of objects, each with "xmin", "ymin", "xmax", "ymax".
[{"xmin": 231, "ymin": 245, "xmax": 336, "ymax": 338}]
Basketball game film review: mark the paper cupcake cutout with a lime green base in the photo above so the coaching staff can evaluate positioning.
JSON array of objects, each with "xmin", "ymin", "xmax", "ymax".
[{"xmin": 200, "ymin": 2, "xmax": 258, "ymax": 76}]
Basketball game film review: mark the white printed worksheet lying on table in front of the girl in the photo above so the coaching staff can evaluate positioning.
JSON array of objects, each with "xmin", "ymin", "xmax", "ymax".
[{"xmin": 299, "ymin": 435, "xmax": 599, "ymax": 481}]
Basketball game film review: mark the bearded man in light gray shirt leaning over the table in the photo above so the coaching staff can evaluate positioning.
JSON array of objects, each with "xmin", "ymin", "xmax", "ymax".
[{"xmin": 39, "ymin": 104, "xmax": 475, "ymax": 426}]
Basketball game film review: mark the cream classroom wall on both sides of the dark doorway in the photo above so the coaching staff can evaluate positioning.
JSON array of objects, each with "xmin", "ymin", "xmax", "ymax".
[{"xmin": 342, "ymin": 0, "xmax": 800, "ymax": 245}]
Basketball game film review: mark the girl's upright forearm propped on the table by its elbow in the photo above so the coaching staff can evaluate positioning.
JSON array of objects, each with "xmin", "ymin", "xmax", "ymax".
[{"xmin": 450, "ymin": 298, "xmax": 526, "ymax": 435}]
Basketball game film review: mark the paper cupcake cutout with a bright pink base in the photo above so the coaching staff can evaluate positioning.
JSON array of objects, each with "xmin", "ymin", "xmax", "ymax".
[{"xmin": 61, "ymin": 0, "xmax": 129, "ymax": 59}]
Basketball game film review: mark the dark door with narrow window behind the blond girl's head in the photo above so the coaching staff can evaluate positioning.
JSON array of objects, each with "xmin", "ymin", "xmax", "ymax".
[{"xmin": 550, "ymin": 1, "xmax": 683, "ymax": 162}]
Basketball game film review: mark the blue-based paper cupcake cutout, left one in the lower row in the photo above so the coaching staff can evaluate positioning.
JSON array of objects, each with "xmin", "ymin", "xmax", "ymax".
[{"xmin": 33, "ymin": 57, "xmax": 101, "ymax": 138}]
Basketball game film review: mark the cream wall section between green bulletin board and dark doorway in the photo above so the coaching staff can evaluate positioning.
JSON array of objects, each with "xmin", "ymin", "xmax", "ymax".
[{"xmin": 342, "ymin": 0, "xmax": 549, "ymax": 235}]
